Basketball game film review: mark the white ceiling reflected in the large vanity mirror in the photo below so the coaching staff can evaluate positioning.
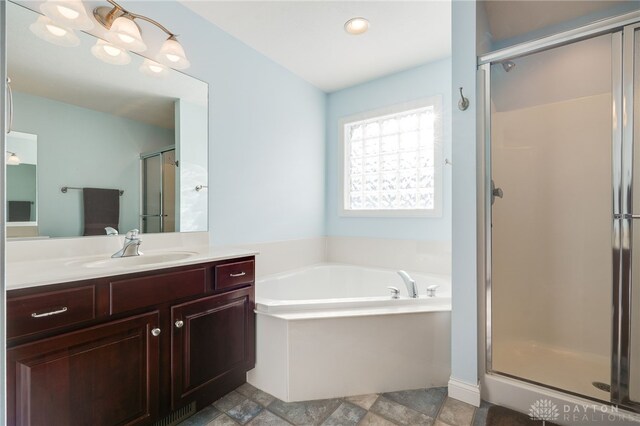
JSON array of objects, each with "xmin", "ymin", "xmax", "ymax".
[{"xmin": 7, "ymin": 2, "xmax": 207, "ymax": 128}]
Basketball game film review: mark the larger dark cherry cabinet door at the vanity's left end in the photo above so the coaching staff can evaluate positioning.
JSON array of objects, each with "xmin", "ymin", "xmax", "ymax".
[{"xmin": 7, "ymin": 311, "xmax": 159, "ymax": 426}]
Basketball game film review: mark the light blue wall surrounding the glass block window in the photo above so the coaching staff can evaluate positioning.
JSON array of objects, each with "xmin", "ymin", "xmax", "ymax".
[{"xmin": 325, "ymin": 59, "xmax": 451, "ymax": 240}]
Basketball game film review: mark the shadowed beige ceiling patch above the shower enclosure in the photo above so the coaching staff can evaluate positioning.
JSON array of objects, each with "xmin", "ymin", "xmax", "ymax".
[{"xmin": 481, "ymin": 0, "xmax": 629, "ymax": 41}]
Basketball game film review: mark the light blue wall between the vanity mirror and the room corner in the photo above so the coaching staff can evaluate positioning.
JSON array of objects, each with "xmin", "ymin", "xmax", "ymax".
[{"xmin": 132, "ymin": 1, "xmax": 326, "ymax": 245}]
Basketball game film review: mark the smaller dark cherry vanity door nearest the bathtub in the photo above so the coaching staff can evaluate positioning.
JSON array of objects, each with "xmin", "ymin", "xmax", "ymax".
[{"xmin": 171, "ymin": 287, "xmax": 255, "ymax": 409}]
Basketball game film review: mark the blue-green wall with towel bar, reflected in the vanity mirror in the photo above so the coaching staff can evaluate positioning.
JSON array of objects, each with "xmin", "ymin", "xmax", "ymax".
[{"xmin": 13, "ymin": 91, "xmax": 174, "ymax": 237}]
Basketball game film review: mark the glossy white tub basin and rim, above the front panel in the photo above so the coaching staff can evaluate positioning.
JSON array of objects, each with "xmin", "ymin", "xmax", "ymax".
[{"xmin": 256, "ymin": 263, "xmax": 451, "ymax": 320}]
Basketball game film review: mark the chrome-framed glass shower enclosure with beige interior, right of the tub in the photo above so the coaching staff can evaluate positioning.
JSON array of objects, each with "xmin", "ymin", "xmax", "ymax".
[{"xmin": 488, "ymin": 18, "xmax": 640, "ymax": 411}]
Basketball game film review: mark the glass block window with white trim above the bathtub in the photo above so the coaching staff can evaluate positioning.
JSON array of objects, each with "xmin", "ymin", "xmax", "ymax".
[{"xmin": 343, "ymin": 98, "xmax": 441, "ymax": 212}]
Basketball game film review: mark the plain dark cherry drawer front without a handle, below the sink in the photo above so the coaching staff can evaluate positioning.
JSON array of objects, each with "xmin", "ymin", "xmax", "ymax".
[{"xmin": 109, "ymin": 268, "xmax": 206, "ymax": 314}]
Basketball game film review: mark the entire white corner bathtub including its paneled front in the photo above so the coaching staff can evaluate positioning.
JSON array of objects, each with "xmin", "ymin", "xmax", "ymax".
[{"xmin": 248, "ymin": 264, "xmax": 451, "ymax": 401}]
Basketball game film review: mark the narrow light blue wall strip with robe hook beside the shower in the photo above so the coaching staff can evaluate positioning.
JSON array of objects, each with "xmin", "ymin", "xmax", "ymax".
[{"xmin": 451, "ymin": 0, "xmax": 478, "ymax": 386}]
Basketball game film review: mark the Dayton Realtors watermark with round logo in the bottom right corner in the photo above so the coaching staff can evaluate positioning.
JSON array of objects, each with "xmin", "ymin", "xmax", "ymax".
[{"xmin": 529, "ymin": 399, "xmax": 640, "ymax": 425}]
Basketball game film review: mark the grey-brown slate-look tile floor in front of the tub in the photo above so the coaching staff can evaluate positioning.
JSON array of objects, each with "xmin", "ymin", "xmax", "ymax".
[{"xmin": 179, "ymin": 383, "xmax": 489, "ymax": 426}]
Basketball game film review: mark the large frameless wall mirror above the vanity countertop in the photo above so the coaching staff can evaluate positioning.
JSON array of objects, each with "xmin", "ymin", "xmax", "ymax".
[{"xmin": 5, "ymin": 2, "xmax": 208, "ymax": 238}]
